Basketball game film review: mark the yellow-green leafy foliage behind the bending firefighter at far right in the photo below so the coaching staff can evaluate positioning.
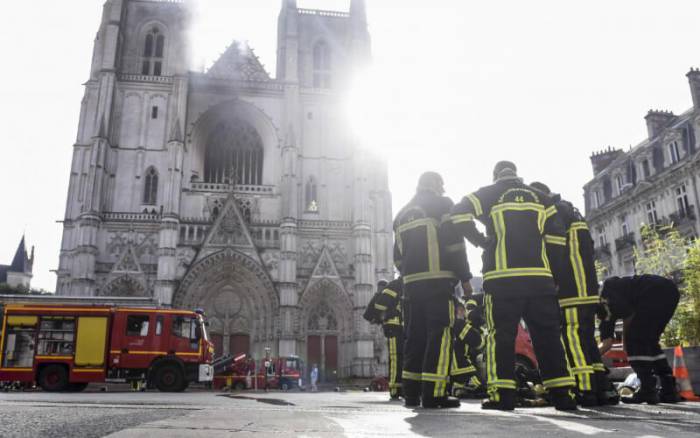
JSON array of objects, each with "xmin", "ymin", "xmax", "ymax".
[{"xmin": 634, "ymin": 225, "xmax": 700, "ymax": 346}]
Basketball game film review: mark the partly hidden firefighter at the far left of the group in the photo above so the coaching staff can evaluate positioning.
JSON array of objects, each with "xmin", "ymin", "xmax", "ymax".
[{"xmin": 374, "ymin": 278, "xmax": 404, "ymax": 400}]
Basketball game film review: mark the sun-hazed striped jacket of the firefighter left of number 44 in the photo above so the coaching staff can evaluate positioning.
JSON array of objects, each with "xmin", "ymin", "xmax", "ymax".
[{"xmin": 394, "ymin": 190, "xmax": 471, "ymax": 286}]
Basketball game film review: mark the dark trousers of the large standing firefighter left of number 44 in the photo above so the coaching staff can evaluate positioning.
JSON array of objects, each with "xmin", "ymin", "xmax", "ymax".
[{"xmin": 402, "ymin": 280, "xmax": 454, "ymax": 400}]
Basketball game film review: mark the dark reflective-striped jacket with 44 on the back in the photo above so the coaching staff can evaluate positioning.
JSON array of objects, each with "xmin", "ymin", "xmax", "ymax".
[{"xmin": 451, "ymin": 178, "xmax": 566, "ymax": 296}]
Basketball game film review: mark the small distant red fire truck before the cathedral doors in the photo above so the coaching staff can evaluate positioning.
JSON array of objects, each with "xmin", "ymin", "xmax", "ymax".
[{"xmin": 214, "ymin": 356, "xmax": 303, "ymax": 391}]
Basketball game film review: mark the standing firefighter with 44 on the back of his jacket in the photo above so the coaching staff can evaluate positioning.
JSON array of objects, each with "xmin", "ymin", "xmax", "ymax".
[{"xmin": 452, "ymin": 161, "xmax": 576, "ymax": 410}]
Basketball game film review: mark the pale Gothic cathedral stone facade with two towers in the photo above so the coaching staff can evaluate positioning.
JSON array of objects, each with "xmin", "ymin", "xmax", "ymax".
[{"xmin": 57, "ymin": 0, "xmax": 393, "ymax": 379}]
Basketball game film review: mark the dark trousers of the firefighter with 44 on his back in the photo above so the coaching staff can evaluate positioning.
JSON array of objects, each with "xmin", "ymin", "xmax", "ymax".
[{"xmin": 485, "ymin": 291, "xmax": 576, "ymax": 402}]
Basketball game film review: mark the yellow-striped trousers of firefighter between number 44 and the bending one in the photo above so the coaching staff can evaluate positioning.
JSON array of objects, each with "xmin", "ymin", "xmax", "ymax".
[{"xmin": 561, "ymin": 304, "xmax": 605, "ymax": 391}]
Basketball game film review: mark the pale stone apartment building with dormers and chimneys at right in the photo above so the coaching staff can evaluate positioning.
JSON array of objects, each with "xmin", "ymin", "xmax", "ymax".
[{"xmin": 584, "ymin": 69, "xmax": 700, "ymax": 275}]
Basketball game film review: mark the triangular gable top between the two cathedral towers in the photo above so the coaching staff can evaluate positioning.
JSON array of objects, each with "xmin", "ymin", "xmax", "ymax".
[{"xmin": 206, "ymin": 41, "xmax": 270, "ymax": 81}]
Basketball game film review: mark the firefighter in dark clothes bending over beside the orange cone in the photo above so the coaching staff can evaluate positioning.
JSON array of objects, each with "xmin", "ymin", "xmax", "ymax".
[{"xmin": 599, "ymin": 275, "xmax": 680, "ymax": 405}]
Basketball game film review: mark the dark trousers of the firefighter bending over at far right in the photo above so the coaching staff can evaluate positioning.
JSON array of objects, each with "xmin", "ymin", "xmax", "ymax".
[{"xmin": 624, "ymin": 288, "xmax": 679, "ymax": 390}]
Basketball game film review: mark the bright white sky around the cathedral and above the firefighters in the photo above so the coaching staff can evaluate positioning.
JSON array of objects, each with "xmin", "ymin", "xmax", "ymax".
[{"xmin": 0, "ymin": 0, "xmax": 700, "ymax": 291}]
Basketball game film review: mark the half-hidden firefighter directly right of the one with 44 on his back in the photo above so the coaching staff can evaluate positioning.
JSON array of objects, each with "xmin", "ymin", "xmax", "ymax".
[{"xmin": 530, "ymin": 182, "xmax": 618, "ymax": 406}]
